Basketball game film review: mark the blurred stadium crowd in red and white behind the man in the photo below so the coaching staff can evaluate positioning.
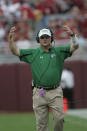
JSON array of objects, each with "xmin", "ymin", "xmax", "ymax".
[{"xmin": 0, "ymin": 0, "xmax": 87, "ymax": 43}]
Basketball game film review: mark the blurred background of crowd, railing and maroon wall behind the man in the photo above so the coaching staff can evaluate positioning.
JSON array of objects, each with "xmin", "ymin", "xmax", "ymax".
[{"xmin": 0, "ymin": 0, "xmax": 87, "ymax": 112}]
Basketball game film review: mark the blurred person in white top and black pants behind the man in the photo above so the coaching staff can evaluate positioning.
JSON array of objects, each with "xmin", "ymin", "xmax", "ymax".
[{"xmin": 61, "ymin": 67, "xmax": 74, "ymax": 108}]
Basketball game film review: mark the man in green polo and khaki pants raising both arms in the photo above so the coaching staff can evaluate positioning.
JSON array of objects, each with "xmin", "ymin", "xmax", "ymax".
[{"xmin": 9, "ymin": 26, "xmax": 78, "ymax": 131}]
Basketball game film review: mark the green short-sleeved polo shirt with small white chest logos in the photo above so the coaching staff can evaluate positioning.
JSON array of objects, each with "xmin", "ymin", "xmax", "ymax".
[{"xmin": 20, "ymin": 45, "xmax": 72, "ymax": 87}]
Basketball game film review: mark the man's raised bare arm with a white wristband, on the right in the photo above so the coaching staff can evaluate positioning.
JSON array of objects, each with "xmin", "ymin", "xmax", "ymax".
[{"xmin": 64, "ymin": 26, "xmax": 79, "ymax": 52}]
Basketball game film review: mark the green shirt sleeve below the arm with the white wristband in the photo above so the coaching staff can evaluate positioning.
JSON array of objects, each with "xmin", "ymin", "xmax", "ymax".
[{"xmin": 56, "ymin": 45, "xmax": 72, "ymax": 59}]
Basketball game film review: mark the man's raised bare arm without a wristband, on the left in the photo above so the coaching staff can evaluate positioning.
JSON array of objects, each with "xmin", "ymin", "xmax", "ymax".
[{"xmin": 8, "ymin": 27, "xmax": 20, "ymax": 56}]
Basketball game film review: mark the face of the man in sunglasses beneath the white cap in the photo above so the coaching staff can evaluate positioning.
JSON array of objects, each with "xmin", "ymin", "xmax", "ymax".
[{"xmin": 39, "ymin": 35, "xmax": 51, "ymax": 47}]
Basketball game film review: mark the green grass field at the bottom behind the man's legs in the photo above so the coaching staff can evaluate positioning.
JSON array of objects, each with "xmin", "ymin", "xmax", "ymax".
[{"xmin": 0, "ymin": 113, "xmax": 87, "ymax": 131}]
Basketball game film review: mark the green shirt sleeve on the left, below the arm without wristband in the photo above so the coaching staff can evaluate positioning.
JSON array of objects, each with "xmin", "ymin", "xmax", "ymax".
[{"xmin": 19, "ymin": 49, "xmax": 35, "ymax": 63}]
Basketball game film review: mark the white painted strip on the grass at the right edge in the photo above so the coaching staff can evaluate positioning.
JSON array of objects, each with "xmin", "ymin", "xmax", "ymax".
[{"xmin": 66, "ymin": 109, "xmax": 87, "ymax": 119}]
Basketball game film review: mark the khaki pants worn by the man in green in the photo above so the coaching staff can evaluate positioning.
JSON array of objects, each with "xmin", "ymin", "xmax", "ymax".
[{"xmin": 33, "ymin": 87, "xmax": 64, "ymax": 131}]
